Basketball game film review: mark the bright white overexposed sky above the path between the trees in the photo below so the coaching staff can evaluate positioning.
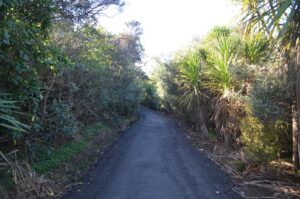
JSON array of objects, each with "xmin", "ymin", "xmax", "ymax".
[{"xmin": 99, "ymin": 0, "xmax": 239, "ymax": 73}]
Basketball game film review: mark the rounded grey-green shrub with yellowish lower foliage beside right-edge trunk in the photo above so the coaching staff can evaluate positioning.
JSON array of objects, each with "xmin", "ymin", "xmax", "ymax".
[{"xmin": 241, "ymin": 73, "xmax": 292, "ymax": 161}]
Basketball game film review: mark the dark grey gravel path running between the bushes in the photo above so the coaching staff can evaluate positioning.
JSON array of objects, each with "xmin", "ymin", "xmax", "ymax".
[{"xmin": 62, "ymin": 109, "xmax": 239, "ymax": 199}]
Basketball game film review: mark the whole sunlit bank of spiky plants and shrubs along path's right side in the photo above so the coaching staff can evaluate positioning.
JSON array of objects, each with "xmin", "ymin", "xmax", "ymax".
[{"xmin": 152, "ymin": 0, "xmax": 300, "ymax": 197}]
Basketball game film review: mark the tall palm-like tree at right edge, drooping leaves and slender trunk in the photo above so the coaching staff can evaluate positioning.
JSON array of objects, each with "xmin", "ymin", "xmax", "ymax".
[{"xmin": 242, "ymin": 0, "xmax": 300, "ymax": 170}]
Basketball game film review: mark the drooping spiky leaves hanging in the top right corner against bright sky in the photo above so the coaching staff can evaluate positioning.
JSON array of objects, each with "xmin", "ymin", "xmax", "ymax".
[{"xmin": 241, "ymin": 0, "xmax": 300, "ymax": 50}]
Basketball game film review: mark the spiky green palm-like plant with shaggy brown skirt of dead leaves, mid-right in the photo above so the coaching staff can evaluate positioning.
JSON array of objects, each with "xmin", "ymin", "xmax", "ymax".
[{"xmin": 205, "ymin": 27, "xmax": 243, "ymax": 144}]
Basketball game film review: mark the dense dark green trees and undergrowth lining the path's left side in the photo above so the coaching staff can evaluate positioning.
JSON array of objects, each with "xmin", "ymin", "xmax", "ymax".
[{"xmin": 0, "ymin": 0, "xmax": 146, "ymax": 198}]
